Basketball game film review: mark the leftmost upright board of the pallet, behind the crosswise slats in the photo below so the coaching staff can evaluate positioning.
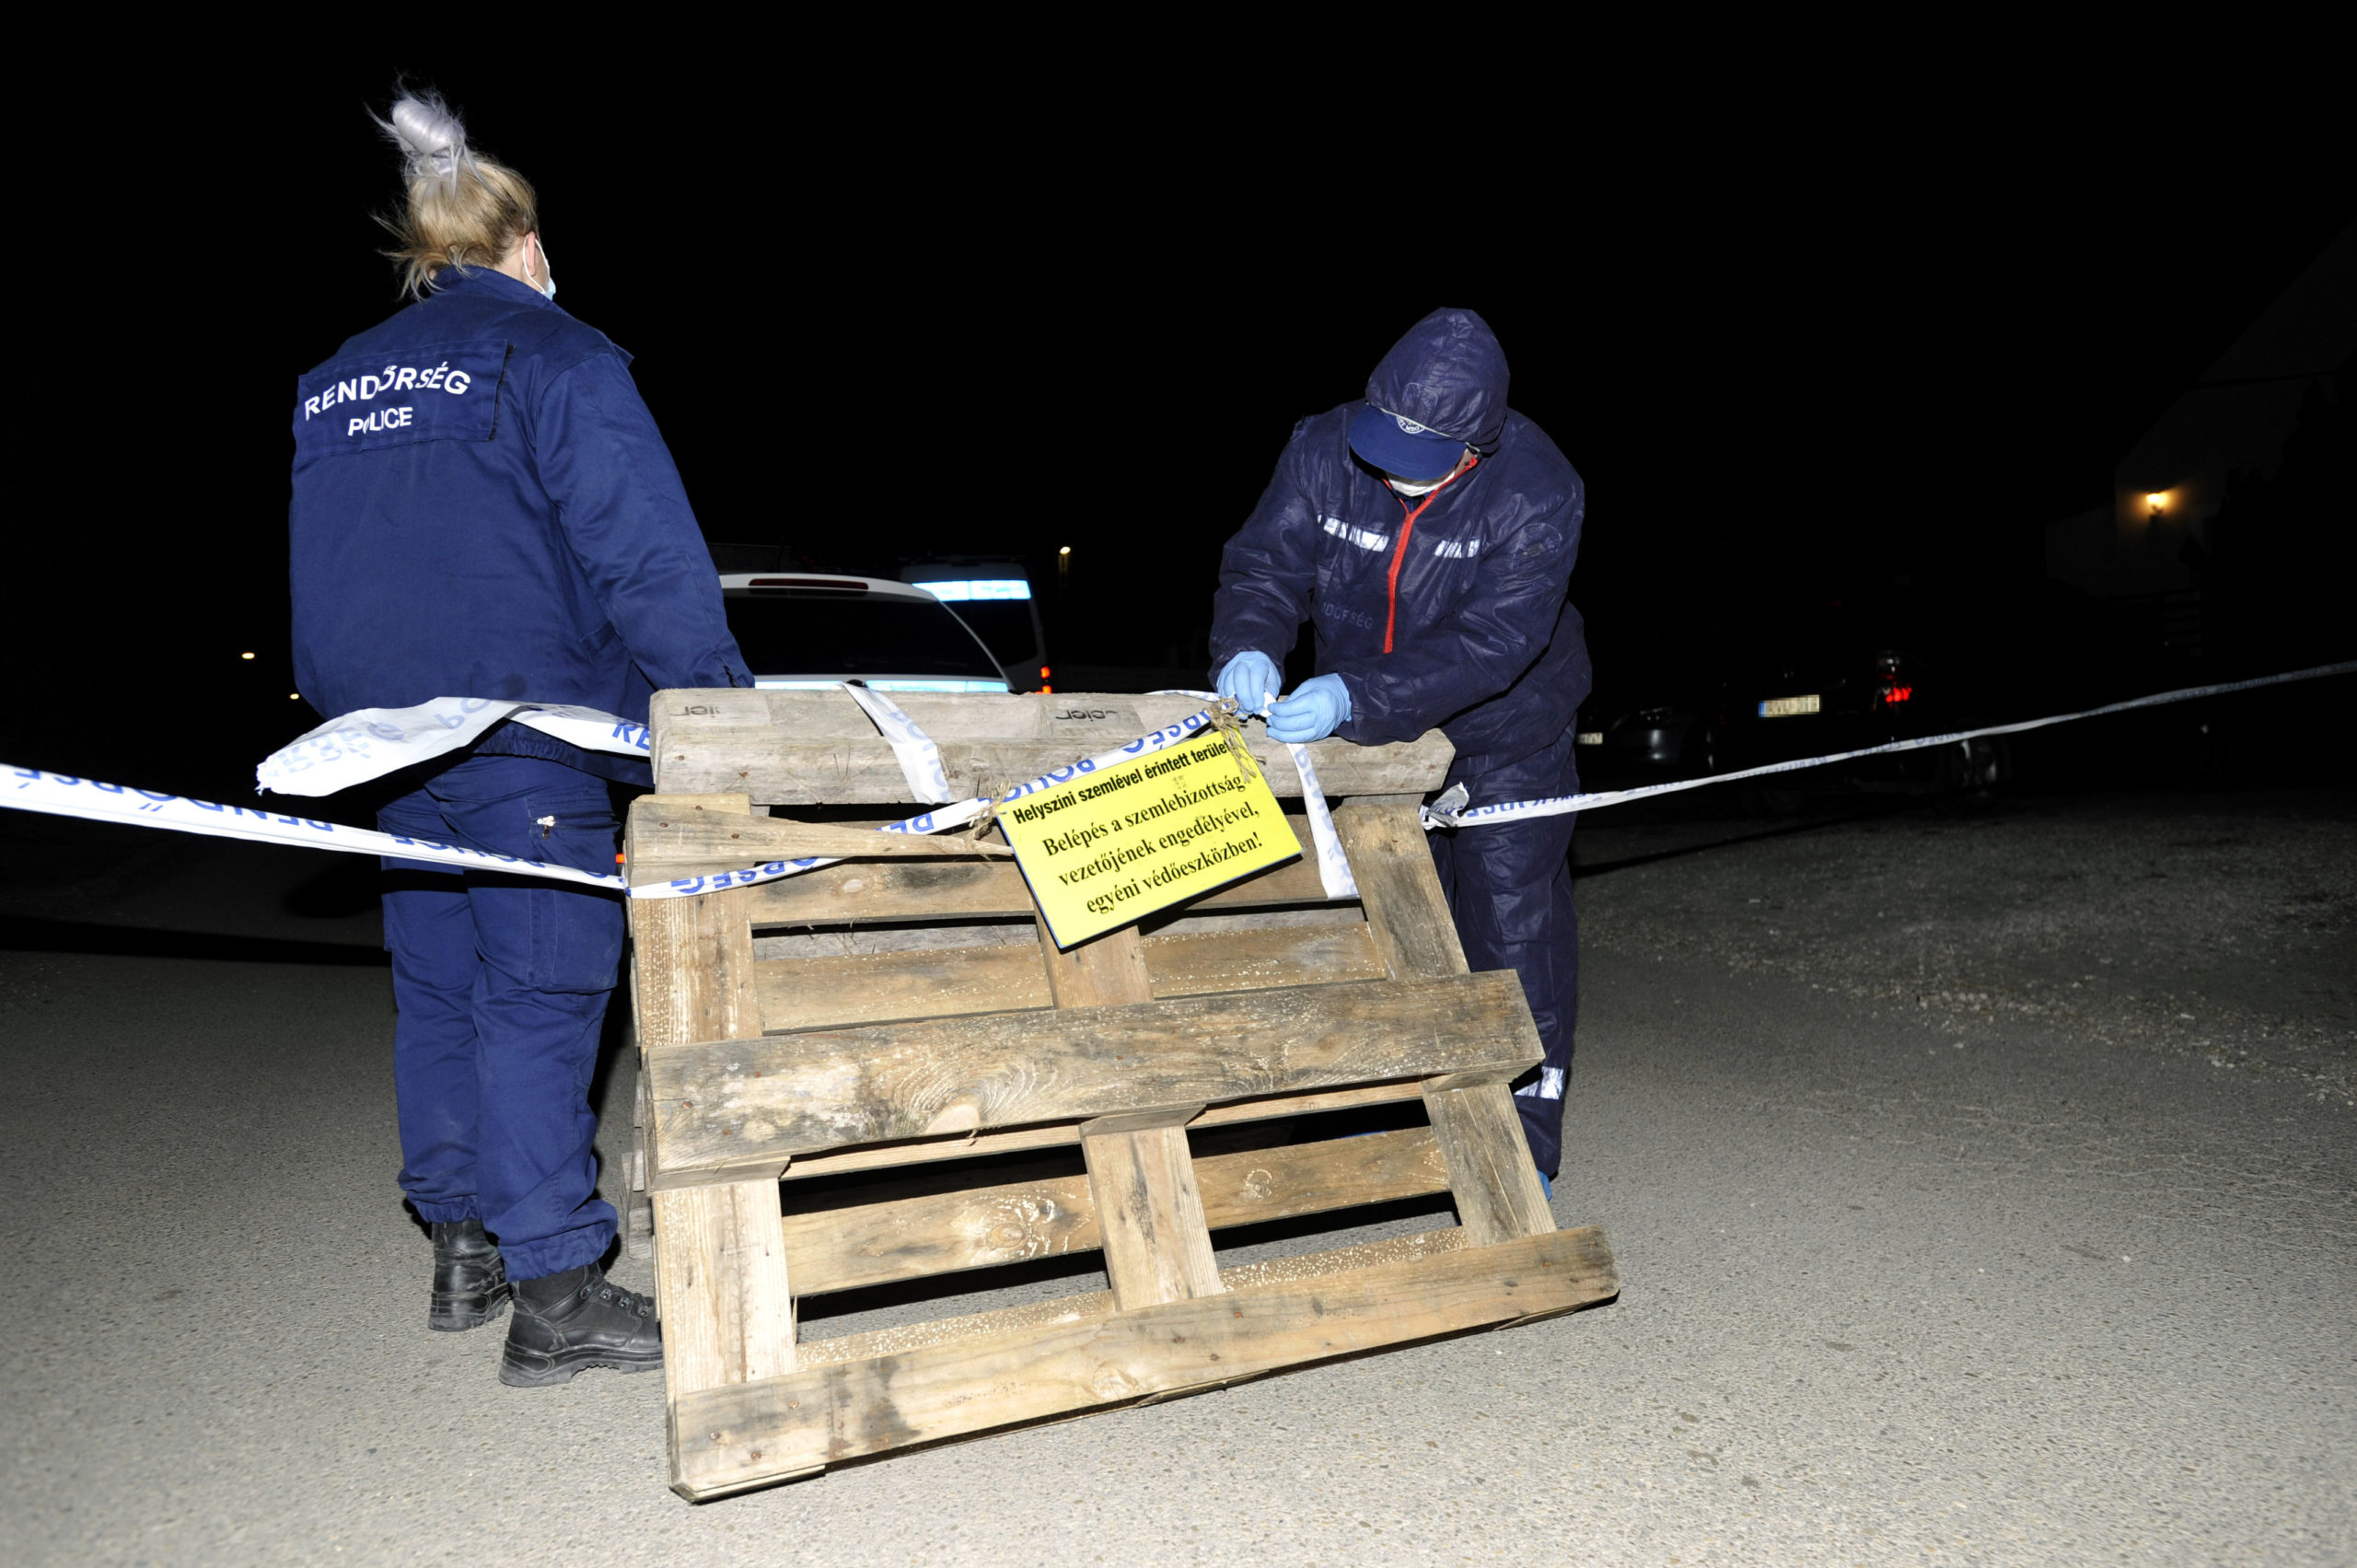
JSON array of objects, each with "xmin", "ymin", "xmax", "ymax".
[{"xmin": 630, "ymin": 797, "xmax": 795, "ymax": 1403}]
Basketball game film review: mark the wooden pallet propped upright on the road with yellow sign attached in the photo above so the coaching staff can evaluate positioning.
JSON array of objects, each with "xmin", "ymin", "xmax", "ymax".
[{"xmin": 630, "ymin": 691, "xmax": 1620, "ymax": 1500}]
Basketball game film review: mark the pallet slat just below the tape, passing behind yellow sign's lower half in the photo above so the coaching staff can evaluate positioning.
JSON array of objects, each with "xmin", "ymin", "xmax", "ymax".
[{"xmin": 745, "ymin": 819, "xmax": 1327, "ymax": 926}]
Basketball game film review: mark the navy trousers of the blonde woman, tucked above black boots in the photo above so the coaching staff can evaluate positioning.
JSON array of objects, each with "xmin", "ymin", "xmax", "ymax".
[{"xmin": 377, "ymin": 757, "xmax": 622, "ymax": 1281}]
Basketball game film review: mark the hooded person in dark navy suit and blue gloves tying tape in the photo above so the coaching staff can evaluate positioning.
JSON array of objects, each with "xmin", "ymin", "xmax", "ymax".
[{"xmin": 1212, "ymin": 308, "xmax": 1591, "ymax": 1181}]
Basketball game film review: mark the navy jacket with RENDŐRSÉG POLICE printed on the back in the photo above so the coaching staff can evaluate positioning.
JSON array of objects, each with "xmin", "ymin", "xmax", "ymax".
[{"xmin": 290, "ymin": 269, "xmax": 752, "ymax": 749}]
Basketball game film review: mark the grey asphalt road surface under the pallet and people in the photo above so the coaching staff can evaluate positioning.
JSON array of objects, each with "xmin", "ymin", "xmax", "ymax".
[{"xmin": 0, "ymin": 792, "xmax": 2357, "ymax": 1565}]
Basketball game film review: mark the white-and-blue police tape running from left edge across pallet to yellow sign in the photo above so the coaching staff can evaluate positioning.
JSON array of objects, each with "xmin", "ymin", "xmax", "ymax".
[{"xmin": 0, "ymin": 710, "xmax": 1212, "ymax": 899}]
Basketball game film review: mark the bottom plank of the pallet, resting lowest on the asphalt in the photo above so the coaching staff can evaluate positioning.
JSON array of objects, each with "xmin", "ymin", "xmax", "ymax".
[{"xmin": 672, "ymin": 1228, "xmax": 1620, "ymax": 1497}]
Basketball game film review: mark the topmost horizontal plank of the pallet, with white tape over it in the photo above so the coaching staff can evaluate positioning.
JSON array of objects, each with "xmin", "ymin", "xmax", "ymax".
[{"xmin": 651, "ymin": 691, "xmax": 1452, "ymax": 804}]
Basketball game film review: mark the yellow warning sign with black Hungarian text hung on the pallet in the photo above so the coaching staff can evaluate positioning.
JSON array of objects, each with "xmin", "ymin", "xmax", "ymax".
[{"xmin": 999, "ymin": 731, "xmax": 1301, "ymax": 947}]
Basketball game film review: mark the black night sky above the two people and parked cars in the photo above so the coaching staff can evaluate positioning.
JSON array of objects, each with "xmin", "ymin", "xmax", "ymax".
[{"xmin": 18, "ymin": 50, "xmax": 2357, "ymax": 783}]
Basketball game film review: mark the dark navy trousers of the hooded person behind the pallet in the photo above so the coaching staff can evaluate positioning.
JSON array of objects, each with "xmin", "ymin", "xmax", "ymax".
[{"xmin": 1431, "ymin": 736, "xmax": 1579, "ymax": 1181}]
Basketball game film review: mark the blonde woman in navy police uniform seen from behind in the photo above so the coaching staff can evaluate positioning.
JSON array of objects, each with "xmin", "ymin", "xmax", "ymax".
[{"xmin": 290, "ymin": 94, "xmax": 749, "ymax": 1387}]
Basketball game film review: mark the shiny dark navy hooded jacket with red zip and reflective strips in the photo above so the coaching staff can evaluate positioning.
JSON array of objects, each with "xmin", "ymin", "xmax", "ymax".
[{"xmin": 1212, "ymin": 311, "xmax": 1591, "ymax": 778}]
